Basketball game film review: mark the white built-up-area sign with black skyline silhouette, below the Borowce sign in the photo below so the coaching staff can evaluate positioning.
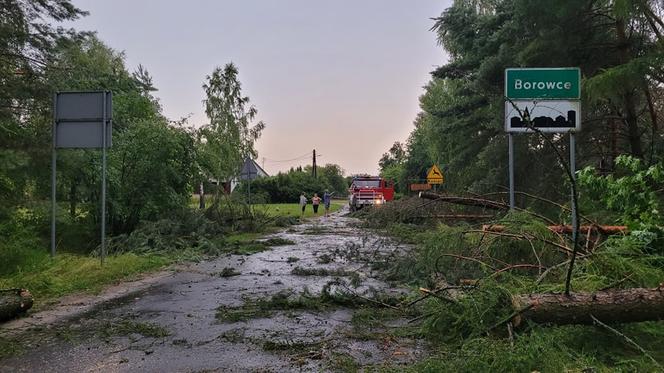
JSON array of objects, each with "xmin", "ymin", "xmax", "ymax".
[{"xmin": 505, "ymin": 100, "xmax": 581, "ymax": 132}]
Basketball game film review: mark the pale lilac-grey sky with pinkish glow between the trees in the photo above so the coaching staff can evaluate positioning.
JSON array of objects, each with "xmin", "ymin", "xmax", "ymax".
[{"xmin": 66, "ymin": 0, "xmax": 451, "ymax": 174}]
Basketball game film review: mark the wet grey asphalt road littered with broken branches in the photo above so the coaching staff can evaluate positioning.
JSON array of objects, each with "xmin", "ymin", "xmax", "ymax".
[{"xmin": 0, "ymin": 211, "xmax": 425, "ymax": 372}]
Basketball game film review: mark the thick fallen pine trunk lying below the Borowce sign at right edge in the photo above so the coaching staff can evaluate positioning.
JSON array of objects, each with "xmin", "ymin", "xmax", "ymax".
[{"xmin": 512, "ymin": 286, "xmax": 664, "ymax": 325}]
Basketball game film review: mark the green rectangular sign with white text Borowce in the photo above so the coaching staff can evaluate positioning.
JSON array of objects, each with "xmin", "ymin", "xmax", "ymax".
[{"xmin": 505, "ymin": 67, "xmax": 581, "ymax": 100}]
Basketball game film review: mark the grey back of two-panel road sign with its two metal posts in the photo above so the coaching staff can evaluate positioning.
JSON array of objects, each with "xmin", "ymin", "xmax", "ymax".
[{"xmin": 51, "ymin": 91, "xmax": 113, "ymax": 264}]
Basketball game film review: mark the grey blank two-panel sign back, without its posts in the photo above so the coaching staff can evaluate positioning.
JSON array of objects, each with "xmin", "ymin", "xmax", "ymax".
[{"xmin": 55, "ymin": 91, "xmax": 113, "ymax": 148}]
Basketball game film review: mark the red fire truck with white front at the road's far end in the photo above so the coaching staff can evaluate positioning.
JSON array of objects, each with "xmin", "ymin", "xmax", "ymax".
[{"xmin": 348, "ymin": 176, "xmax": 394, "ymax": 211}]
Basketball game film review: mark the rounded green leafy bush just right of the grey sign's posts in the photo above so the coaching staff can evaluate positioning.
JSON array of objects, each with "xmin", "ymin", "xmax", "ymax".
[{"xmin": 108, "ymin": 120, "xmax": 195, "ymax": 234}]
